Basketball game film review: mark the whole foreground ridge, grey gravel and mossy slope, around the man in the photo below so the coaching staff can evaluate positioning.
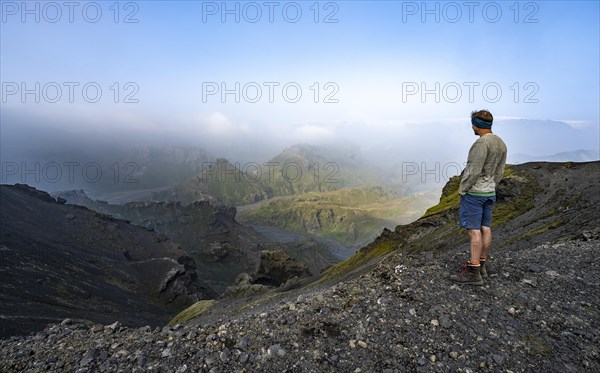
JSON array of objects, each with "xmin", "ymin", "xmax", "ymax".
[{"xmin": 0, "ymin": 162, "xmax": 600, "ymax": 373}]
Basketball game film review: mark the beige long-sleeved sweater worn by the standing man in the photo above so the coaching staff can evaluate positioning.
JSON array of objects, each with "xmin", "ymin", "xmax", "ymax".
[{"xmin": 458, "ymin": 133, "xmax": 506, "ymax": 195}]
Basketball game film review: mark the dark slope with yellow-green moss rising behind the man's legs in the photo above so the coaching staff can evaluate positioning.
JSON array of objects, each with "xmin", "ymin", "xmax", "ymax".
[{"xmin": 323, "ymin": 162, "xmax": 600, "ymax": 280}]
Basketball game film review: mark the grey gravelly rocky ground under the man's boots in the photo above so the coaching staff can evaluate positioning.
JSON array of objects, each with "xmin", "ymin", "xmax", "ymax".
[{"xmin": 0, "ymin": 230, "xmax": 600, "ymax": 372}]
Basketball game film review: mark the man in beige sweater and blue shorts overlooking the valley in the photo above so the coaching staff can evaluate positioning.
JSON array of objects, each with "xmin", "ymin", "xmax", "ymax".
[{"xmin": 450, "ymin": 110, "xmax": 506, "ymax": 285}]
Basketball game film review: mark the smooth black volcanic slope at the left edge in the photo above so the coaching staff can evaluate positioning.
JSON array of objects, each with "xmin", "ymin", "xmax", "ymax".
[{"xmin": 0, "ymin": 185, "xmax": 211, "ymax": 336}]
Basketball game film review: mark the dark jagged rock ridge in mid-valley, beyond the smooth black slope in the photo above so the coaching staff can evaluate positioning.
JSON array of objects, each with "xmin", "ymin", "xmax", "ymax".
[{"xmin": 56, "ymin": 190, "xmax": 336, "ymax": 292}]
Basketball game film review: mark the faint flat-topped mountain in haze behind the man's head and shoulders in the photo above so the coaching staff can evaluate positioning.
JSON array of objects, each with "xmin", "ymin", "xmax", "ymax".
[{"xmin": 363, "ymin": 118, "xmax": 600, "ymax": 168}]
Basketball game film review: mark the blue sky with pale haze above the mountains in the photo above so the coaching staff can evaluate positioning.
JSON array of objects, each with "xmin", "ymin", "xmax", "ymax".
[{"xmin": 0, "ymin": 1, "xmax": 600, "ymax": 161}]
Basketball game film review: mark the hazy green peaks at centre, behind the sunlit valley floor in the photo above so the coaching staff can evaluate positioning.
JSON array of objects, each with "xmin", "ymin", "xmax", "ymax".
[{"xmin": 152, "ymin": 144, "xmax": 382, "ymax": 205}]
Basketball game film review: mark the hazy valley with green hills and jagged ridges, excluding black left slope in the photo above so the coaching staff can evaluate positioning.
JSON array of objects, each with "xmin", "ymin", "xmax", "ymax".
[{"xmin": 54, "ymin": 144, "xmax": 439, "ymax": 284}]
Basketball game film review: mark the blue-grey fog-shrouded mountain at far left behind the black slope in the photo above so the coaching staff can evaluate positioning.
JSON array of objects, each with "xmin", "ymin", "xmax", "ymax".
[{"xmin": 0, "ymin": 142, "xmax": 214, "ymax": 202}]
